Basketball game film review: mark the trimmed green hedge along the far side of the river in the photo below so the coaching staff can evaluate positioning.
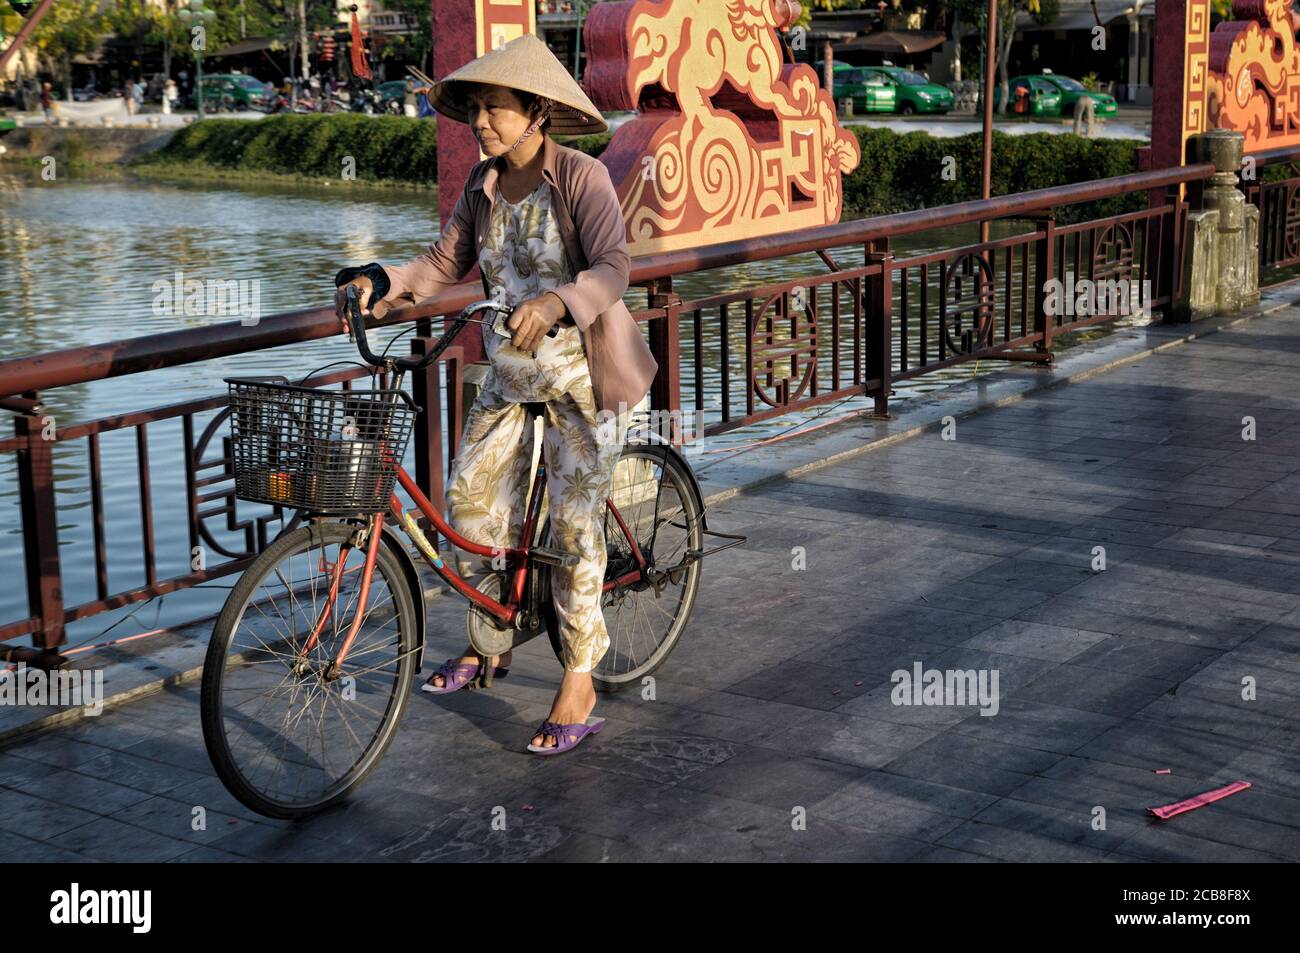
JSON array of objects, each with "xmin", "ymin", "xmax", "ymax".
[{"xmin": 139, "ymin": 113, "xmax": 1147, "ymax": 221}]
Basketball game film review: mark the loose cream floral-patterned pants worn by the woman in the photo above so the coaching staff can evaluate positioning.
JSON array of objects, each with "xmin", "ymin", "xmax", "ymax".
[{"xmin": 446, "ymin": 319, "xmax": 631, "ymax": 672}]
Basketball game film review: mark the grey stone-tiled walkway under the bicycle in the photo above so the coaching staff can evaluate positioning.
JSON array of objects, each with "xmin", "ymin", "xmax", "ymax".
[{"xmin": 0, "ymin": 308, "xmax": 1300, "ymax": 862}]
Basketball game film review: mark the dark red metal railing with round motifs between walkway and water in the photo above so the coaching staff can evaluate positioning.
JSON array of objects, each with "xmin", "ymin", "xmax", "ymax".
[{"xmin": 0, "ymin": 156, "xmax": 1294, "ymax": 663}]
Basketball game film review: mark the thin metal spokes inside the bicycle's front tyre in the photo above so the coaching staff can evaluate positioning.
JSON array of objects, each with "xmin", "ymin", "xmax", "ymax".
[{"xmin": 209, "ymin": 524, "xmax": 416, "ymax": 807}]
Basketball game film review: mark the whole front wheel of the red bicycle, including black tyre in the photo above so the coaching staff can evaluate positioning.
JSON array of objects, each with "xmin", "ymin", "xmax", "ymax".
[{"xmin": 200, "ymin": 520, "xmax": 423, "ymax": 819}]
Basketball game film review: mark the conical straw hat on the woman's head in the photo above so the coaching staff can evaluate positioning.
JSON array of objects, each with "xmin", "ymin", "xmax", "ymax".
[{"xmin": 429, "ymin": 33, "xmax": 610, "ymax": 135}]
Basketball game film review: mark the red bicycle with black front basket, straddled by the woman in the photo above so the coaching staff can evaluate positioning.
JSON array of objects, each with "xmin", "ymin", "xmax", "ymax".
[{"xmin": 200, "ymin": 287, "xmax": 746, "ymax": 819}]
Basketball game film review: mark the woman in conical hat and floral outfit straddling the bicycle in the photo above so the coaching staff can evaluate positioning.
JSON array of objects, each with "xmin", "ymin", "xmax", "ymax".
[{"xmin": 335, "ymin": 34, "xmax": 658, "ymax": 750}]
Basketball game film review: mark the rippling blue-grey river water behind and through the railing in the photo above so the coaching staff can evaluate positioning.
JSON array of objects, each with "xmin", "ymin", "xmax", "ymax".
[{"xmin": 0, "ymin": 172, "xmax": 1144, "ymax": 642}]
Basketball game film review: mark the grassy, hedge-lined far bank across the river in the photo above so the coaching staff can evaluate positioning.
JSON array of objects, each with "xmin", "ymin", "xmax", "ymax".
[{"xmin": 0, "ymin": 114, "xmax": 1145, "ymax": 221}]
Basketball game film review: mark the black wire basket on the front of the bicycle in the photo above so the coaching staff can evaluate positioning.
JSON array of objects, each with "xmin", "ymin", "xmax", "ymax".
[{"xmin": 226, "ymin": 378, "xmax": 417, "ymax": 515}]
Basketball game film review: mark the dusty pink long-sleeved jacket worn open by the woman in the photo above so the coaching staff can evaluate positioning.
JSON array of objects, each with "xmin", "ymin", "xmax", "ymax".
[{"xmin": 372, "ymin": 135, "xmax": 659, "ymax": 413}]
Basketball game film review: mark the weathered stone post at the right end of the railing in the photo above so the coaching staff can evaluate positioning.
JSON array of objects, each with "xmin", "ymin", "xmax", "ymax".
[{"xmin": 1174, "ymin": 129, "xmax": 1260, "ymax": 321}]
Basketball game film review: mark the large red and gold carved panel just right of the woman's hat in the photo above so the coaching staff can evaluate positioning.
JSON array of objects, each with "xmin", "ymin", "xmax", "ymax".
[{"xmin": 585, "ymin": 0, "xmax": 861, "ymax": 255}]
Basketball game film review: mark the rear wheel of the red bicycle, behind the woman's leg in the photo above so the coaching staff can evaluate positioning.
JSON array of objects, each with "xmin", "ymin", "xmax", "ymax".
[{"xmin": 540, "ymin": 443, "xmax": 705, "ymax": 692}]
